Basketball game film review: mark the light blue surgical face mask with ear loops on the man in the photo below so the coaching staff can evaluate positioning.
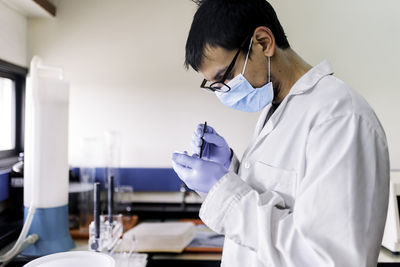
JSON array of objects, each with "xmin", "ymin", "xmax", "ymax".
[{"xmin": 215, "ymin": 39, "xmax": 274, "ymax": 112}]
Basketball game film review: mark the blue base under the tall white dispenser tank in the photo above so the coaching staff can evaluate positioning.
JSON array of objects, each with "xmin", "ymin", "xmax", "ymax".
[{"xmin": 21, "ymin": 205, "xmax": 75, "ymax": 256}]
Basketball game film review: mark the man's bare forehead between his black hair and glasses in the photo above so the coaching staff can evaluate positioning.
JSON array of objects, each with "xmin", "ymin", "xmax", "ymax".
[{"xmin": 200, "ymin": 46, "xmax": 235, "ymax": 80}]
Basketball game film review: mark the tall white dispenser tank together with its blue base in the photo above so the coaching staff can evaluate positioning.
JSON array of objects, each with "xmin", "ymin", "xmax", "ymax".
[{"xmin": 23, "ymin": 57, "xmax": 74, "ymax": 256}]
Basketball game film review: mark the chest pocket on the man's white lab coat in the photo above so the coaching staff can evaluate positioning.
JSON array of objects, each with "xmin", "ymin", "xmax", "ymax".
[{"xmin": 252, "ymin": 161, "xmax": 297, "ymax": 207}]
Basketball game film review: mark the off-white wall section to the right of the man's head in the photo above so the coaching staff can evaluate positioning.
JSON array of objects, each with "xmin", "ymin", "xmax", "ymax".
[{"xmin": 270, "ymin": 0, "xmax": 400, "ymax": 168}]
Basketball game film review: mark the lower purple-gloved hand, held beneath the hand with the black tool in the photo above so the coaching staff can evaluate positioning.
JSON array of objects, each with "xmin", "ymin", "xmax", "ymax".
[{"xmin": 172, "ymin": 153, "xmax": 228, "ymax": 193}]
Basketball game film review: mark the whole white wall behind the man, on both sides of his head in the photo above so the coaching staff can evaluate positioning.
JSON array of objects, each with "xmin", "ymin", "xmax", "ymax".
[{"xmin": 29, "ymin": 0, "xmax": 400, "ymax": 168}]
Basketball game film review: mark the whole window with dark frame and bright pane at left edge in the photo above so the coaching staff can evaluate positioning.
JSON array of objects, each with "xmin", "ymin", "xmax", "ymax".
[{"xmin": 0, "ymin": 60, "xmax": 27, "ymax": 168}]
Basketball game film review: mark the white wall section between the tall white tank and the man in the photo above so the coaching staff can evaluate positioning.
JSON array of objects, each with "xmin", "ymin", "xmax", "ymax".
[{"xmin": 28, "ymin": 0, "xmax": 257, "ymax": 167}]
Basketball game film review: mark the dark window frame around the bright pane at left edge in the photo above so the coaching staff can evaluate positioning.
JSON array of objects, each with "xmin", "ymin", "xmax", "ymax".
[{"xmin": 0, "ymin": 59, "xmax": 28, "ymax": 170}]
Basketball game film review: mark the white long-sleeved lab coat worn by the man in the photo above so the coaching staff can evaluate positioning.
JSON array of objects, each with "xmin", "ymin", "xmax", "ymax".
[{"xmin": 200, "ymin": 61, "xmax": 389, "ymax": 267}]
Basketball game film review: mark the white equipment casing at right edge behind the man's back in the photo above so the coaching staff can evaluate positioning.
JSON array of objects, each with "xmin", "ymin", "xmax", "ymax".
[{"xmin": 382, "ymin": 171, "xmax": 400, "ymax": 253}]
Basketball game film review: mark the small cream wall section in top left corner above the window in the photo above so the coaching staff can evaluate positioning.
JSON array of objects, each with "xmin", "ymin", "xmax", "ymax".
[{"xmin": 0, "ymin": 1, "xmax": 28, "ymax": 67}]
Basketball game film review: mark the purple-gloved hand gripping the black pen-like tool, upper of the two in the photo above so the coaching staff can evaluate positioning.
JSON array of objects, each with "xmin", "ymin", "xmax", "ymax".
[{"xmin": 190, "ymin": 124, "xmax": 232, "ymax": 169}]
